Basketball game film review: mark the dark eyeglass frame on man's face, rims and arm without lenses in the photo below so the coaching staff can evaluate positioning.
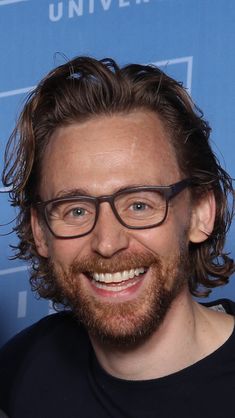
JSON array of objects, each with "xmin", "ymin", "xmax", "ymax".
[{"xmin": 35, "ymin": 178, "xmax": 192, "ymax": 239}]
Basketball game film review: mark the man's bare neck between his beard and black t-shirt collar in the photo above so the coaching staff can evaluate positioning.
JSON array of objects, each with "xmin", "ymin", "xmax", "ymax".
[{"xmin": 91, "ymin": 289, "xmax": 233, "ymax": 380}]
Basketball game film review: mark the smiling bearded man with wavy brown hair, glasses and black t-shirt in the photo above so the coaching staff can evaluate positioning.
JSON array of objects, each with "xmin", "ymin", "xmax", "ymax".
[{"xmin": 0, "ymin": 57, "xmax": 235, "ymax": 418}]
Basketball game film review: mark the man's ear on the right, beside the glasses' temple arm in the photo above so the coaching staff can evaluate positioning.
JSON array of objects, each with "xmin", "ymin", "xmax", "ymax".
[{"xmin": 189, "ymin": 192, "xmax": 216, "ymax": 243}]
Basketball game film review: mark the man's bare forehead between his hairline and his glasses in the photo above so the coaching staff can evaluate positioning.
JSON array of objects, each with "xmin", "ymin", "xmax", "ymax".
[{"xmin": 41, "ymin": 110, "xmax": 180, "ymax": 199}]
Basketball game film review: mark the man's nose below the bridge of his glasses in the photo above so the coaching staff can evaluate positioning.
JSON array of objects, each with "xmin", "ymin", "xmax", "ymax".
[{"xmin": 91, "ymin": 202, "xmax": 129, "ymax": 258}]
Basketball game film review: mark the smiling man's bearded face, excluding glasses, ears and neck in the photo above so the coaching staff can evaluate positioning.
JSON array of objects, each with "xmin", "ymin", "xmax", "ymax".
[{"xmin": 32, "ymin": 110, "xmax": 195, "ymax": 345}]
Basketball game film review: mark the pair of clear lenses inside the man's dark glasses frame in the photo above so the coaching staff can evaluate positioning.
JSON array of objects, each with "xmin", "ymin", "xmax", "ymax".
[{"xmin": 46, "ymin": 191, "xmax": 167, "ymax": 237}]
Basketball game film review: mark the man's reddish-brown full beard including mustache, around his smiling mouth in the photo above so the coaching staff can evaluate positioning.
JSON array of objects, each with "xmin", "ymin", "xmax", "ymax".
[{"xmin": 50, "ymin": 245, "xmax": 190, "ymax": 349}]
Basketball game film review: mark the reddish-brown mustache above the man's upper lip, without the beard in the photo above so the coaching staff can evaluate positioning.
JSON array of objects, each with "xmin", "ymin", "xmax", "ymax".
[{"xmin": 69, "ymin": 253, "xmax": 162, "ymax": 275}]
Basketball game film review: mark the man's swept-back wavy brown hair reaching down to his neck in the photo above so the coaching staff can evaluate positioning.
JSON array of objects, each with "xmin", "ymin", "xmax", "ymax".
[{"xmin": 3, "ymin": 57, "xmax": 234, "ymax": 303}]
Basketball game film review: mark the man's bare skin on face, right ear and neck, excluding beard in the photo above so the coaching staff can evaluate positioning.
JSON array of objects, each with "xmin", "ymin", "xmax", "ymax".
[{"xmin": 32, "ymin": 110, "xmax": 233, "ymax": 379}]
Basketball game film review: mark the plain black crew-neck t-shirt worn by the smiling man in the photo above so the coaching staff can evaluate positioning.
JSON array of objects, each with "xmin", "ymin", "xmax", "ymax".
[{"xmin": 0, "ymin": 300, "xmax": 235, "ymax": 418}]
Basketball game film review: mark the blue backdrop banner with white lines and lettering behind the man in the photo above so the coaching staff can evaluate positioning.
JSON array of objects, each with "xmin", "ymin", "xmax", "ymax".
[{"xmin": 0, "ymin": 0, "xmax": 235, "ymax": 344}]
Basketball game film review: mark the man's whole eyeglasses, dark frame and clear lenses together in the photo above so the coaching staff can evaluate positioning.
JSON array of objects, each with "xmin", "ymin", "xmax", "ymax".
[{"xmin": 34, "ymin": 179, "xmax": 191, "ymax": 239}]
